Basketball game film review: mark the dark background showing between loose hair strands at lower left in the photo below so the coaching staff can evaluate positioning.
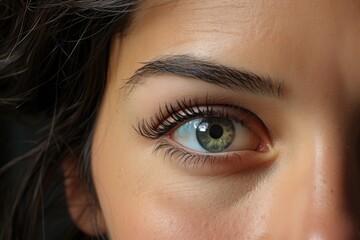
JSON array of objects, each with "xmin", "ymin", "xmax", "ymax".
[{"xmin": 0, "ymin": 112, "xmax": 74, "ymax": 240}]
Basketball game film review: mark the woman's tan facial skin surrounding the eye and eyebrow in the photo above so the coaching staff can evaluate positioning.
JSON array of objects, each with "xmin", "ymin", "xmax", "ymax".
[{"xmin": 77, "ymin": 0, "xmax": 360, "ymax": 240}]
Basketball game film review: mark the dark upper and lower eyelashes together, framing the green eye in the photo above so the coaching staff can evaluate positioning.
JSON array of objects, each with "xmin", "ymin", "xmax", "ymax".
[{"xmin": 134, "ymin": 97, "xmax": 259, "ymax": 167}]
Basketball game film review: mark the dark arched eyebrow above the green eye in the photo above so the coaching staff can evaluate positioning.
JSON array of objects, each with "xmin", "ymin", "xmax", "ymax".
[{"xmin": 126, "ymin": 55, "xmax": 284, "ymax": 99}]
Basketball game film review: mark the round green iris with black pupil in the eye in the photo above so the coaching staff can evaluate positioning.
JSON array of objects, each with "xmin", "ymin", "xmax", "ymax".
[{"xmin": 196, "ymin": 117, "xmax": 235, "ymax": 152}]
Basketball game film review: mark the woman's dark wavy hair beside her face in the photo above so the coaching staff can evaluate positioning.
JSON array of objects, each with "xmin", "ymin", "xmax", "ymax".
[{"xmin": 0, "ymin": 0, "xmax": 138, "ymax": 240}]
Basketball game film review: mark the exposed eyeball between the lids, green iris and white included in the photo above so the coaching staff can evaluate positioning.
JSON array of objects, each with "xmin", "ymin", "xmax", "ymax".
[{"xmin": 169, "ymin": 117, "xmax": 261, "ymax": 153}]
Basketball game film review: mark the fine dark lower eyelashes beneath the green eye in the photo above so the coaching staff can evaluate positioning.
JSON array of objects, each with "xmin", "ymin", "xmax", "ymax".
[{"xmin": 153, "ymin": 139, "xmax": 240, "ymax": 168}]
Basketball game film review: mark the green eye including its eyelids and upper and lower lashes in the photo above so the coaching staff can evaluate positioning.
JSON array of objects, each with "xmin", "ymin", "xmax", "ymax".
[{"xmin": 134, "ymin": 99, "xmax": 276, "ymax": 172}]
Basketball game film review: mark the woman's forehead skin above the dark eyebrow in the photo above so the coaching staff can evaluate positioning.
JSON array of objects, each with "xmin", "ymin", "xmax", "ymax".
[{"xmin": 121, "ymin": 0, "xmax": 360, "ymax": 100}]
